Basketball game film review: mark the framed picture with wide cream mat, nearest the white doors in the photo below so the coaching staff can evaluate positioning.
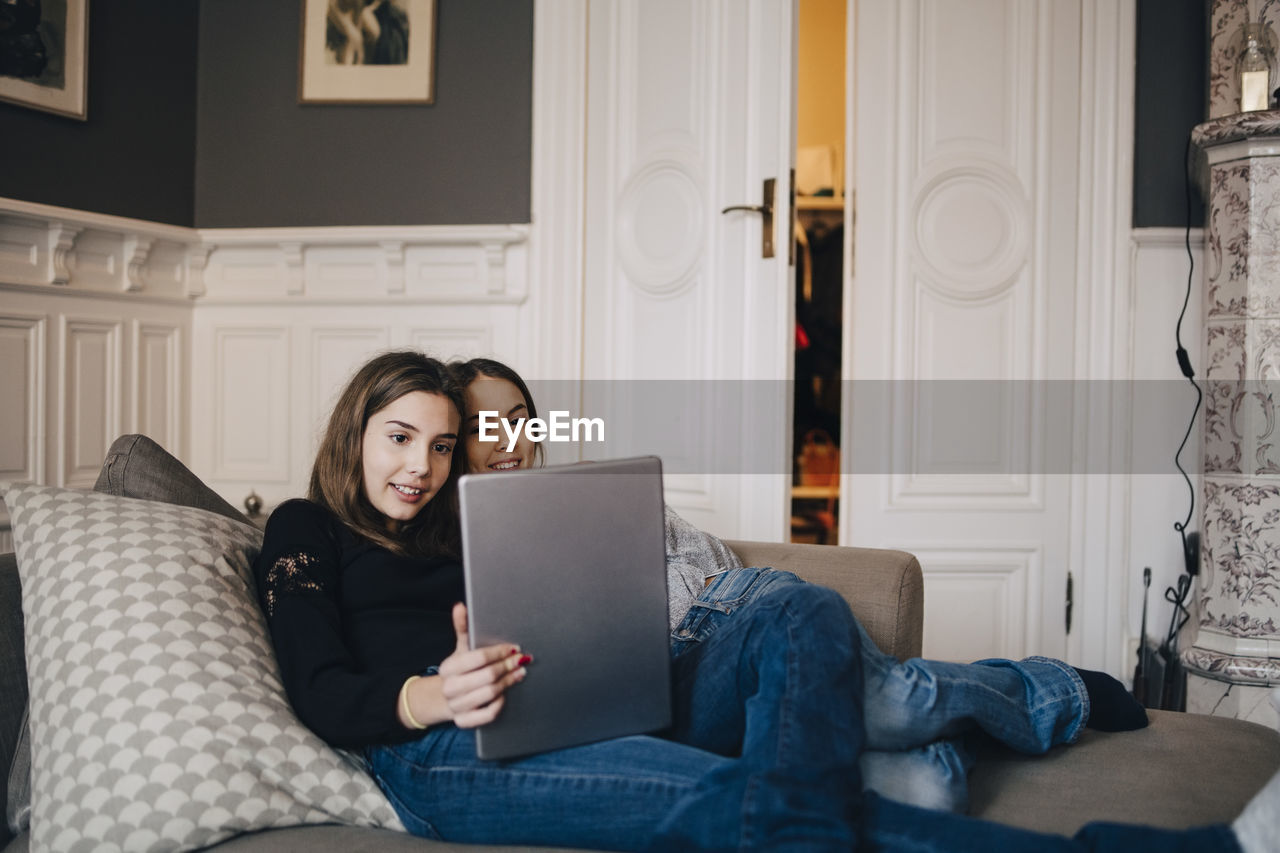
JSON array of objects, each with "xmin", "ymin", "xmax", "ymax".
[{"xmin": 298, "ymin": 0, "xmax": 436, "ymax": 104}]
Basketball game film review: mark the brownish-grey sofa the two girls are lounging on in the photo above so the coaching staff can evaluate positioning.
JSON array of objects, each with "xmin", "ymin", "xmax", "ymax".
[{"xmin": 0, "ymin": 435, "xmax": 1280, "ymax": 853}]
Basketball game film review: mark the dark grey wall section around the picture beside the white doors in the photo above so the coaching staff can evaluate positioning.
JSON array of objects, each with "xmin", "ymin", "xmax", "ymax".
[{"xmin": 195, "ymin": 0, "xmax": 534, "ymax": 228}]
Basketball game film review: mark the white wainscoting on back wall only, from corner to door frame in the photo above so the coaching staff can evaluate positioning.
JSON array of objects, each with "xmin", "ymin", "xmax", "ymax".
[{"xmin": 191, "ymin": 225, "xmax": 531, "ymax": 506}]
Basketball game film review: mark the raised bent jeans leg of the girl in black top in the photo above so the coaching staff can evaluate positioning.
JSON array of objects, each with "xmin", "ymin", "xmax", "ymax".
[{"xmin": 668, "ymin": 571, "xmax": 863, "ymax": 850}]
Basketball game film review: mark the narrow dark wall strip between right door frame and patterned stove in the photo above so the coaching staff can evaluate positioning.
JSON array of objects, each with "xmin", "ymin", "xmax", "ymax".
[{"xmin": 1133, "ymin": 0, "xmax": 1208, "ymax": 228}]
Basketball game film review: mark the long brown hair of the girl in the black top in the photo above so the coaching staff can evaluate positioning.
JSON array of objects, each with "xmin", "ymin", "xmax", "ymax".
[{"xmin": 307, "ymin": 350, "xmax": 466, "ymax": 557}]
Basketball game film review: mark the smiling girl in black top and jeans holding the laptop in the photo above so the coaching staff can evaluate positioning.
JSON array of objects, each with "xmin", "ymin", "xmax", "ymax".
[{"xmin": 247, "ymin": 352, "xmax": 1280, "ymax": 852}]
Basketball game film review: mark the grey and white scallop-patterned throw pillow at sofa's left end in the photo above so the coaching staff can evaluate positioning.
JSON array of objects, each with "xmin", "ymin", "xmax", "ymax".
[{"xmin": 4, "ymin": 484, "xmax": 402, "ymax": 850}]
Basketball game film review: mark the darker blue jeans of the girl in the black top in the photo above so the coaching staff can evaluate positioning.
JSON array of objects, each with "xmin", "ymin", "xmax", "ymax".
[{"xmin": 365, "ymin": 573, "xmax": 1238, "ymax": 853}]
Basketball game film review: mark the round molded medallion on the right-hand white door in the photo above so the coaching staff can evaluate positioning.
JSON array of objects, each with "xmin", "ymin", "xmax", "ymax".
[{"xmin": 914, "ymin": 164, "xmax": 1032, "ymax": 300}]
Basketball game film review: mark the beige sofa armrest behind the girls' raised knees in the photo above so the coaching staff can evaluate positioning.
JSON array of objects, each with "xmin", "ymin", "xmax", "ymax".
[{"xmin": 726, "ymin": 542, "xmax": 924, "ymax": 661}]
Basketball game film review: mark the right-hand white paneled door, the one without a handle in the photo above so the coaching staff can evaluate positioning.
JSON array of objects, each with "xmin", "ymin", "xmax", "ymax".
[{"xmin": 841, "ymin": 0, "xmax": 1133, "ymax": 672}]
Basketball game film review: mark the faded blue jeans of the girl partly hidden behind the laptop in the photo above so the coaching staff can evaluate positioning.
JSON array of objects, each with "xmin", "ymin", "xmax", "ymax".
[{"xmin": 672, "ymin": 569, "xmax": 1089, "ymax": 811}]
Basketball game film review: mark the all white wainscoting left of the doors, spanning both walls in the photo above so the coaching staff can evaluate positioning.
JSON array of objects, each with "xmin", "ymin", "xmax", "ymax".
[{"xmin": 0, "ymin": 199, "xmax": 536, "ymax": 535}]
